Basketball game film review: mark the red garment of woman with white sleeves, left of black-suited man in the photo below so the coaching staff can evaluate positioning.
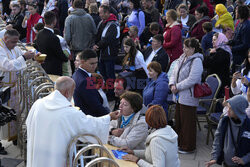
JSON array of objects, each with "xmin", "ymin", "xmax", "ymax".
[{"xmin": 26, "ymin": 13, "xmax": 42, "ymax": 43}]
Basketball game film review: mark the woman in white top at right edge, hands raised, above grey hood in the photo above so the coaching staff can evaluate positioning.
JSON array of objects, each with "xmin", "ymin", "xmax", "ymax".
[{"xmin": 231, "ymin": 49, "xmax": 250, "ymax": 97}]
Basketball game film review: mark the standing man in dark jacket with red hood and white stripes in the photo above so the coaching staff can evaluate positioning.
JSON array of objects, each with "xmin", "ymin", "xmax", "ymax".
[{"xmin": 93, "ymin": 5, "xmax": 120, "ymax": 99}]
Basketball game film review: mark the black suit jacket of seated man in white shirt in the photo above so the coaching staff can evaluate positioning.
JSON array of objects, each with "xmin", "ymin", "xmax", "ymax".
[{"xmin": 143, "ymin": 46, "xmax": 169, "ymax": 72}]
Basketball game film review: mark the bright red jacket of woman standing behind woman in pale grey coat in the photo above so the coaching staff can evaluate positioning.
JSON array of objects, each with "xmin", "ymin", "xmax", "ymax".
[{"xmin": 163, "ymin": 22, "xmax": 183, "ymax": 63}]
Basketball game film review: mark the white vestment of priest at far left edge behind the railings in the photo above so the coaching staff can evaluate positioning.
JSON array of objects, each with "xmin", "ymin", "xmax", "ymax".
[{"xmin": 0, "ymin": 39, "xmax": 26, "ymax": 140}]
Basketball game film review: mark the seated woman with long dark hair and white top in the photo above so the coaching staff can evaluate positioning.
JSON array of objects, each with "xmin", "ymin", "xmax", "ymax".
[{"xmin": 122, "ymin": 38, "xmax": 148, "ymax": 78}]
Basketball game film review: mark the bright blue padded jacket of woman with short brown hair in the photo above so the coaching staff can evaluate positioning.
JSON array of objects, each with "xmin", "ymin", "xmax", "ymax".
[{"xmin": 143, "ymin": 72, "xmax": 168, "ymax": 114}]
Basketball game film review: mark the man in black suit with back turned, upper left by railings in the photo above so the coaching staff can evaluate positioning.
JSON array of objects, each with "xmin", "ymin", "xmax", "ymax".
[{"xmin": 35, "ymin": 11, "xmax": 68, "ymax": 75}]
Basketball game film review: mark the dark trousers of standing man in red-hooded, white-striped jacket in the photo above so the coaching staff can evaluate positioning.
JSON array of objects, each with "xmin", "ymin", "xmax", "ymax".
[{"xmin": 98, "ymin": 60, "xmax": 115, "ymax": 97}]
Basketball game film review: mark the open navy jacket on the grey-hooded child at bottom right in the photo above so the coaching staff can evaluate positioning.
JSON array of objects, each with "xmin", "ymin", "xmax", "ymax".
[{"xmin": 212, "ymin": 116, "xmax": 250, "ymax": 167}]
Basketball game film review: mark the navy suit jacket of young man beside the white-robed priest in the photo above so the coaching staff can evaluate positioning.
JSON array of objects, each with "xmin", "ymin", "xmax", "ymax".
[{"xmin": 72, "ymin": 69, "xmax": 109, "ymax": 117}]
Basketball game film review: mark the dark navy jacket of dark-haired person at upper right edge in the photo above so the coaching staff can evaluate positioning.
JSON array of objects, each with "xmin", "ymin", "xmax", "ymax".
[{"xmin": 232, "ymin": 20, "xmax": 250, "ymax": 65}]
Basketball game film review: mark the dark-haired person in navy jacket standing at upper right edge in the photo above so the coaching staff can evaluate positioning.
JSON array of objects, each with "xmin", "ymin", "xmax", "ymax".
[{"xmin": 230, "ymin": 5, "xmax": 250, "ymax": 71}]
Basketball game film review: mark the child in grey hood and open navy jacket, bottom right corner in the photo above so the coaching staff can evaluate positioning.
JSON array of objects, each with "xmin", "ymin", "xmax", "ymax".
[{"xmin": 206, "ymin": 95, "xmax": 250, "ymax": 167}]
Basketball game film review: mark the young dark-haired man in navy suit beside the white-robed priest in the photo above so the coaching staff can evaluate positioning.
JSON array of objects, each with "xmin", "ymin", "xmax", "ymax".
[{"xmin": 72, "ymin": 49, "xmax": 109, "ymax": 117}]
